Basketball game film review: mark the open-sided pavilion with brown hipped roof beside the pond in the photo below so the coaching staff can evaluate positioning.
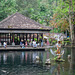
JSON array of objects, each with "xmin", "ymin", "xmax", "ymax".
[{"xmin": 0, "ymin": 12, "xmax": 51, "ymax": 46}]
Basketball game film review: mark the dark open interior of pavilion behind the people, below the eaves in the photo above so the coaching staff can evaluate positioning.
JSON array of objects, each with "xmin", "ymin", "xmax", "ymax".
[{"xmin": 0, "ymin": 33, "xmax": 43, "ymax": 45}]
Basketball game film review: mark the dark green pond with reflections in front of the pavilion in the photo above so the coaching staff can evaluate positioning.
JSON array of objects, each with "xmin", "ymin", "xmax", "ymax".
[{"xmin": 0, "ymin": 48, "xmax": 75, "ymax": 75}]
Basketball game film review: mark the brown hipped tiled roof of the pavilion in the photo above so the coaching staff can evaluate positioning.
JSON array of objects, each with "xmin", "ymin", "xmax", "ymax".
[{"xmin": 0, "ymin": 12, "xmax": 50, "ymax": 30}]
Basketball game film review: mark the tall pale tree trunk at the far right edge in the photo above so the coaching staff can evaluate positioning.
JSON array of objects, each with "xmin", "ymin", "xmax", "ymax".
[{"xmin": 69, "ymin": 0, "xmax": 75, "ymax": 46}]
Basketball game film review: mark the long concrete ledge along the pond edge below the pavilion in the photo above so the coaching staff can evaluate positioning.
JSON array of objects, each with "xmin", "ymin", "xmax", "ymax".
[{"xmin": 0, "ymin": 47, "xmax": 45, "ymax": 51}]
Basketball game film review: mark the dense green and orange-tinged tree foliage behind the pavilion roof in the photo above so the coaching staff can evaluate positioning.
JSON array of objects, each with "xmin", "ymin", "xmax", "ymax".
[{"xmin": 0, "ymin": 0, "xmax": 75, "ymax": 45}]
